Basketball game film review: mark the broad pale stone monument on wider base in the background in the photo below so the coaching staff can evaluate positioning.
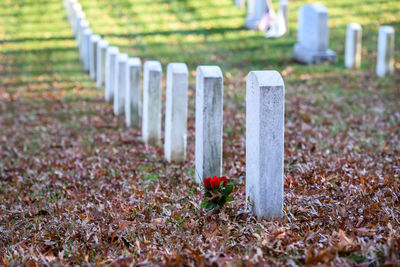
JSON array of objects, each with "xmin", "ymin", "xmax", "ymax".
[{"xmin": 294, "ymin": 3, "xmax": 336, "ymax": 64}]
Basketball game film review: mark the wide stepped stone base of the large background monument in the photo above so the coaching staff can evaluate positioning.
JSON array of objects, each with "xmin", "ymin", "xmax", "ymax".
[{"xmin": 294, "ymin": 43, "xmax": 336, "ymax": 65}]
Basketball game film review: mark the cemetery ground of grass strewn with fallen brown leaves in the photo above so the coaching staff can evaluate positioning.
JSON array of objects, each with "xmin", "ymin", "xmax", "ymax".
[{"xmin": 0, "ymin": 0, "xmax": 400, "ymax": 266}]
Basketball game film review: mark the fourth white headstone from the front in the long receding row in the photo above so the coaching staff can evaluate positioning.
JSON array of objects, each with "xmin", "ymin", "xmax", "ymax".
[{"xmin": 142, "ymin": 61, "xmax": 162, "ymax": 146}]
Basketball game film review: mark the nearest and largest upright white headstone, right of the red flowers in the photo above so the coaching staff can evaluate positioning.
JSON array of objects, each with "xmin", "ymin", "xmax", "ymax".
[{"xmin": 246, "ymin": 71, "xmax": 285, "ymax": 218}]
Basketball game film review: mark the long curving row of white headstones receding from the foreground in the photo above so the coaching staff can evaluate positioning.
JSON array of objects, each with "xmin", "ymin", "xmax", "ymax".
[{"xmin": 63, "ymin": 0, "xmax": 285, "ymax": 218}]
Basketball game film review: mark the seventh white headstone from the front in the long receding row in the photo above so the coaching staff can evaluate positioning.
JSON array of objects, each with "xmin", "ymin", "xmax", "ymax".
[{"xmin": 104, "ymin": 46, "xmax": 119, "ymax": 102}]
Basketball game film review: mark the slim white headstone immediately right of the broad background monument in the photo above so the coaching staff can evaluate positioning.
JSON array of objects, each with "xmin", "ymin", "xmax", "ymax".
[{"xmin": 344, "ymin": 23, "xmax": 361, "ymax": 69}]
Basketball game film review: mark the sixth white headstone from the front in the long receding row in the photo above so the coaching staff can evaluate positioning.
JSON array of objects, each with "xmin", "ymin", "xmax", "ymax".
[{"xmin": 114, "ymin": 53, "xmax": 128, "ymax": 116}]
